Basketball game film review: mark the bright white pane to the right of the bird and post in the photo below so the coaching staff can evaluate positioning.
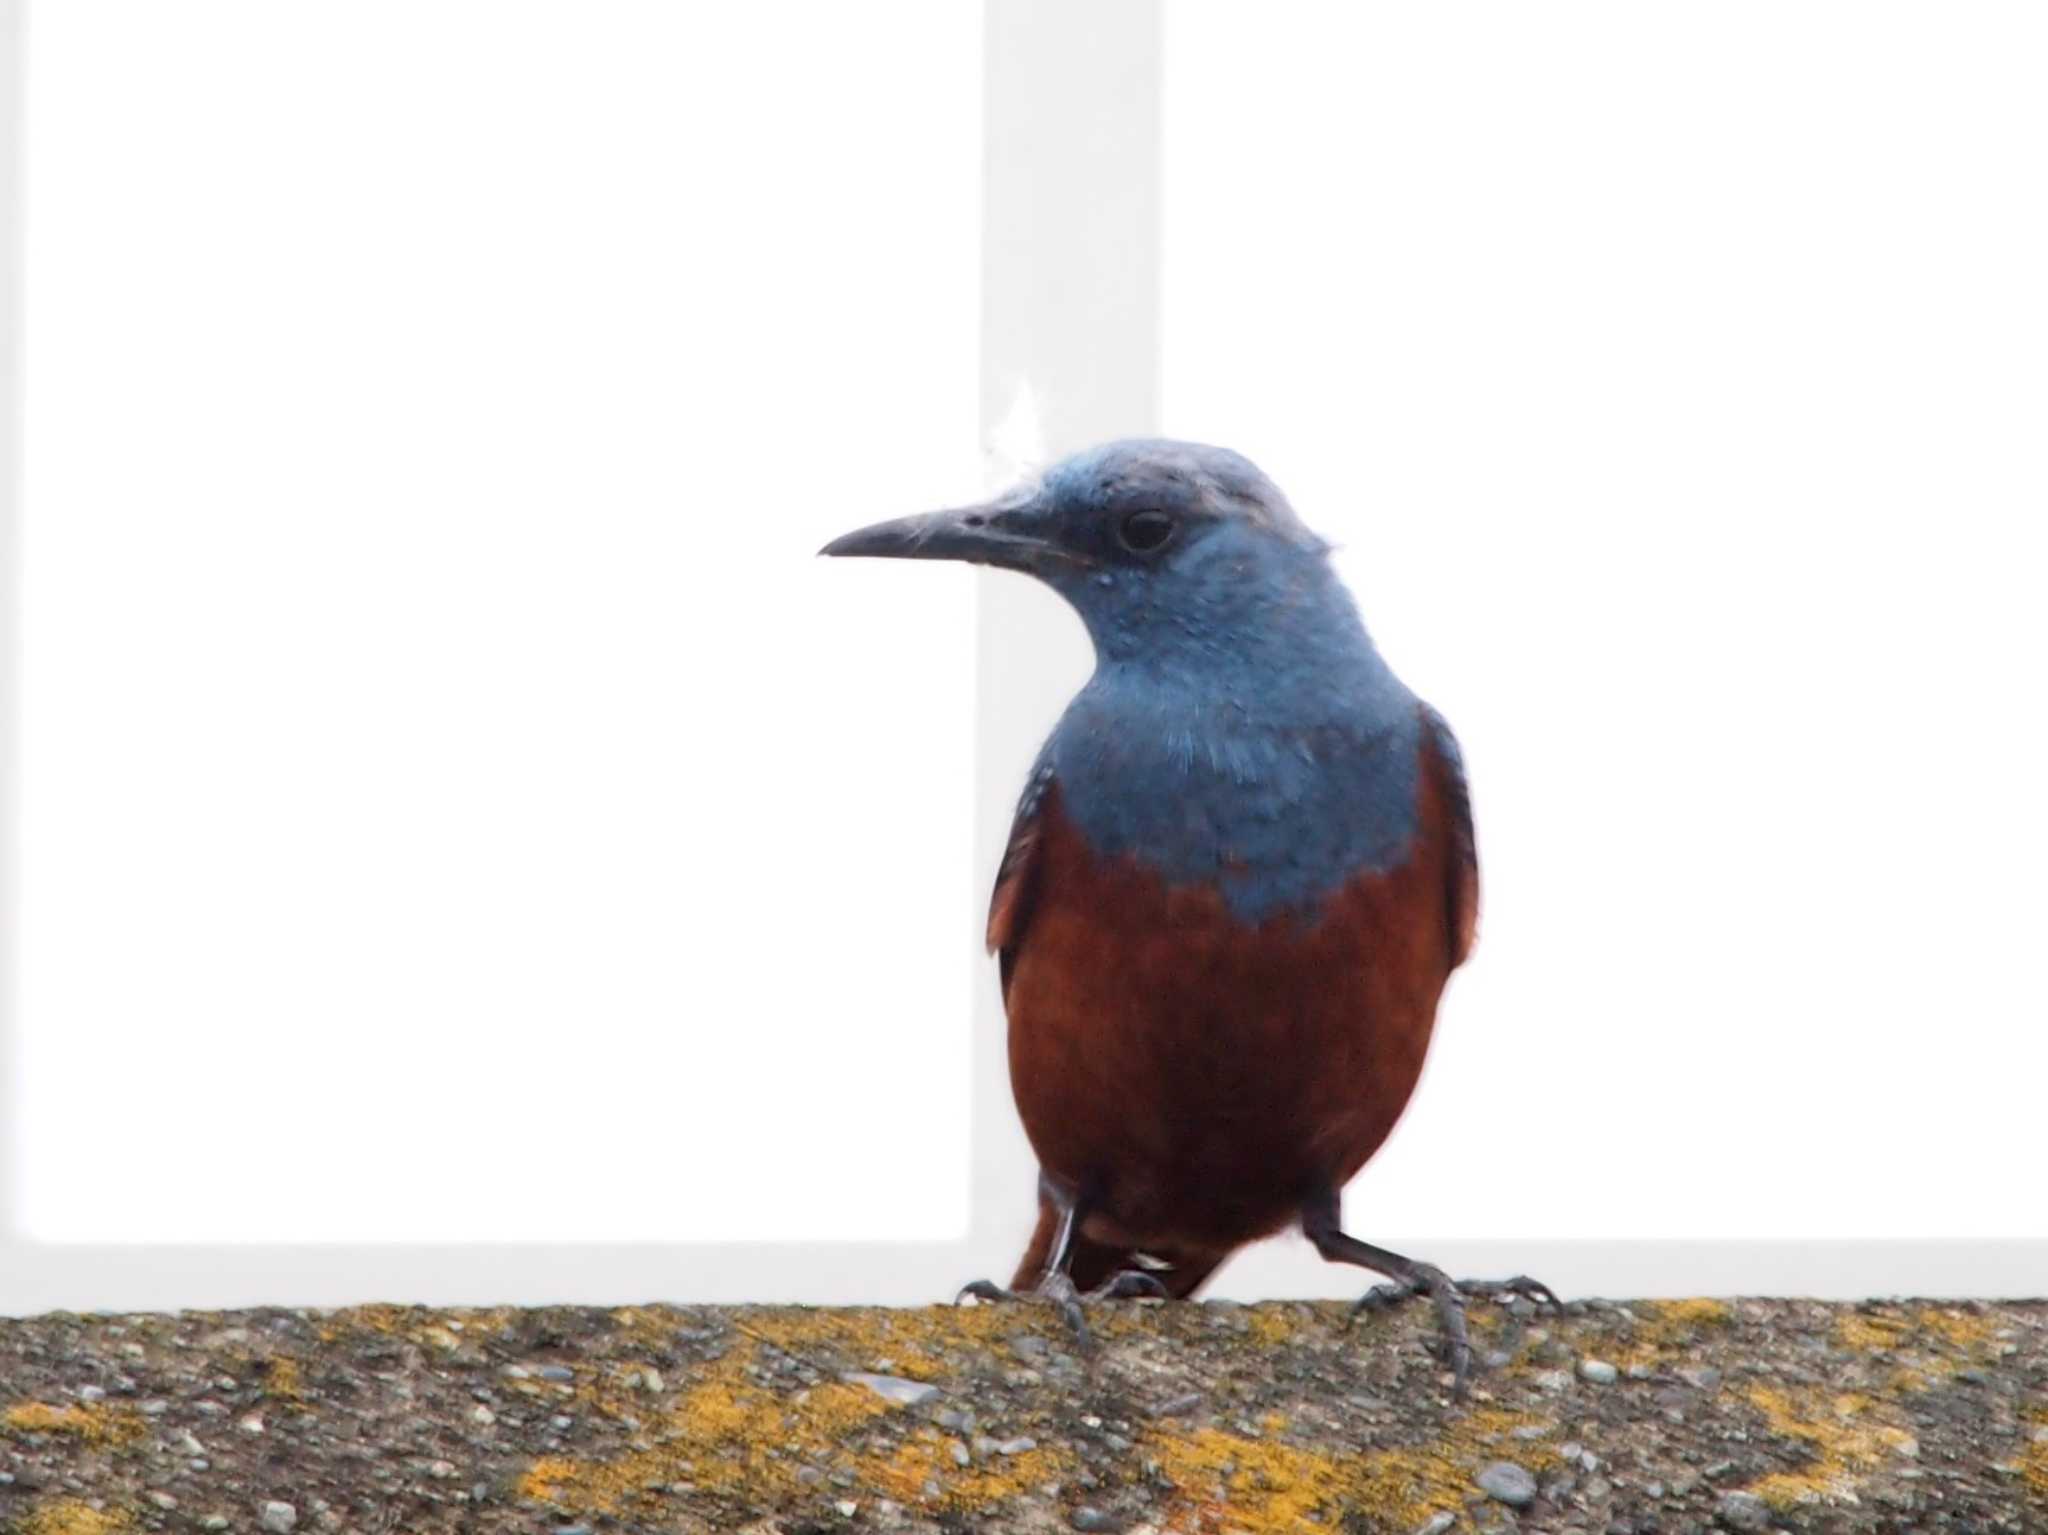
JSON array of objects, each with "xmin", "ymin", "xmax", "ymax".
[{"xmin": 1165, "ymin": 2, "xmax": 2048, "ymax": 1252}]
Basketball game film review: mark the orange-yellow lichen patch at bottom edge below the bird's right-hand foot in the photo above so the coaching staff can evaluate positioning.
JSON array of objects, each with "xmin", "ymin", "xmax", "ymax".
[{"xmin": 1147, "ymin": 1408, "xmax": 1556, "ymax": 1535}]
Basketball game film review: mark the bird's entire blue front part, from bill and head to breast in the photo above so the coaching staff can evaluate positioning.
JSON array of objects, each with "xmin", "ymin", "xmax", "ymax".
[{"xmin": 823, "ymin": 438, "xmax": 1421, "ymax": 919}]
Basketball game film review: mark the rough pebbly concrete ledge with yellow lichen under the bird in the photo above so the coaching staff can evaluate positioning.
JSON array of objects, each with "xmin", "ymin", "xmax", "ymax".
[{"xmin": 0, "ymin": 1300, "xmax": 2048, "ymax": 1535}]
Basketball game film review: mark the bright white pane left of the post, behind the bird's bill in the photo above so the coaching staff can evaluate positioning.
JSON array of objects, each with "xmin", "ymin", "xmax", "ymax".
[{"xmin": 16, "ymin": 0, "xmax": 981, "ymax": 1242}]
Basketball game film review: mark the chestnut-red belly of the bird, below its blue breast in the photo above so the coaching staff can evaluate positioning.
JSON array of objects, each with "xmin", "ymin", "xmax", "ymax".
[{"xmin": 1006, "ymin": 810, "xmax": 1452, "ymax": 1248}]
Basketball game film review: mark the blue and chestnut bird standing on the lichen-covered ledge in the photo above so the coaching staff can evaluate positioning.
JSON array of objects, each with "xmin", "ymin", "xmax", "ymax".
[{"xmin": 819, "ymin": 438, "xmax": 1559, "ymax": 1396}]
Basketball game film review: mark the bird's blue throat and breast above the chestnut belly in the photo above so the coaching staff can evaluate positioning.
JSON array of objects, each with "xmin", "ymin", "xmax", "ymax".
[{"xmin": 1028, "ymin": 526, "xmax": 1423, "ymax": 923}]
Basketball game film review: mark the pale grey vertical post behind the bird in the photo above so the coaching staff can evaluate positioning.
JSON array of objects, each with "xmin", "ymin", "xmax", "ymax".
[{"xmin": 973, "ymin": 0, "xmax": 1161, "ymax": 1279}]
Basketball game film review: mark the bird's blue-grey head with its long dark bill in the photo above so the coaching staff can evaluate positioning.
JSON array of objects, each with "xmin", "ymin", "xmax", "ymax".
[{"xmin": 819, "ymin": 438, "xmax": 1356, "ymax": 659}]
